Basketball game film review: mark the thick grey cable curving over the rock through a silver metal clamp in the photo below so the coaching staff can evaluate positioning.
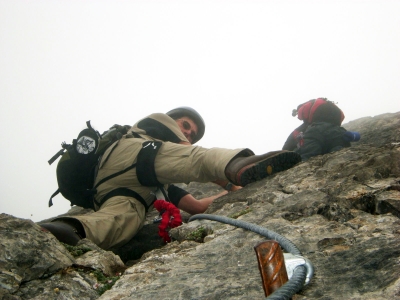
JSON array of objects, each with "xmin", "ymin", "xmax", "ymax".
[{"xmin": 189, "ymin": 214, "xmax": 314, "ymax": 300}]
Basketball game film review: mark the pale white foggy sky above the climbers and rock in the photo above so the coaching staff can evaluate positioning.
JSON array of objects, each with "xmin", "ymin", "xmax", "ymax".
[{"xmin": 0, "ymin": 0, "xmax": 400, "ymax": 221}]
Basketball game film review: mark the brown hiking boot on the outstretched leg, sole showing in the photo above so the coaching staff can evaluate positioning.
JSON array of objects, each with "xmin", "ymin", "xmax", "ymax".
[{"xmin": 225, "ymin": 150, "xmax": 301, "ymax": 186}]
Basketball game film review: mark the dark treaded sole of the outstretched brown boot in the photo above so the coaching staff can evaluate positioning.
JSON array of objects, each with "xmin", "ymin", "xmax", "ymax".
[{"xmin": 237, "ymin": 152, "xmax": 301, "ymax": 186}]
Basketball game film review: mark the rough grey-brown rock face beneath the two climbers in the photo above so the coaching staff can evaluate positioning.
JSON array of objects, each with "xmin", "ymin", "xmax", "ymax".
[{"xmin": 0, "ymin": 113, "xmax": 400, "ymax": 300}]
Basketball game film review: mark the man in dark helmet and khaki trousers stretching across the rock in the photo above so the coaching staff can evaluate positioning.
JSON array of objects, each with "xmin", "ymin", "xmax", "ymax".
[{"xmin": 41, "ymin": 107, "xmax": 301, "ymax": 249}]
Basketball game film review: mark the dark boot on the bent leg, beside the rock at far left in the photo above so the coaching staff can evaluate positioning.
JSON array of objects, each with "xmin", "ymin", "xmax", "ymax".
[{"xmin": 39, "ymin": 221, "xmax": 83, "ymax": 246}]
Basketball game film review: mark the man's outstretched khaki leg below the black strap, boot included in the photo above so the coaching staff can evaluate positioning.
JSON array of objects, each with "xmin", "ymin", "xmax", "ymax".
[{"xmin": 155, "ymin": 143, "xmax": 301, "ymax": 186}]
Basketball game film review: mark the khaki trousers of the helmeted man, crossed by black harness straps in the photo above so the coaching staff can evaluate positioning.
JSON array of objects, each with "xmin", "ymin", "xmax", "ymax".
[{"xmin": 58, "ymin": 138, "xmax": 248, "ymax": 249}]
